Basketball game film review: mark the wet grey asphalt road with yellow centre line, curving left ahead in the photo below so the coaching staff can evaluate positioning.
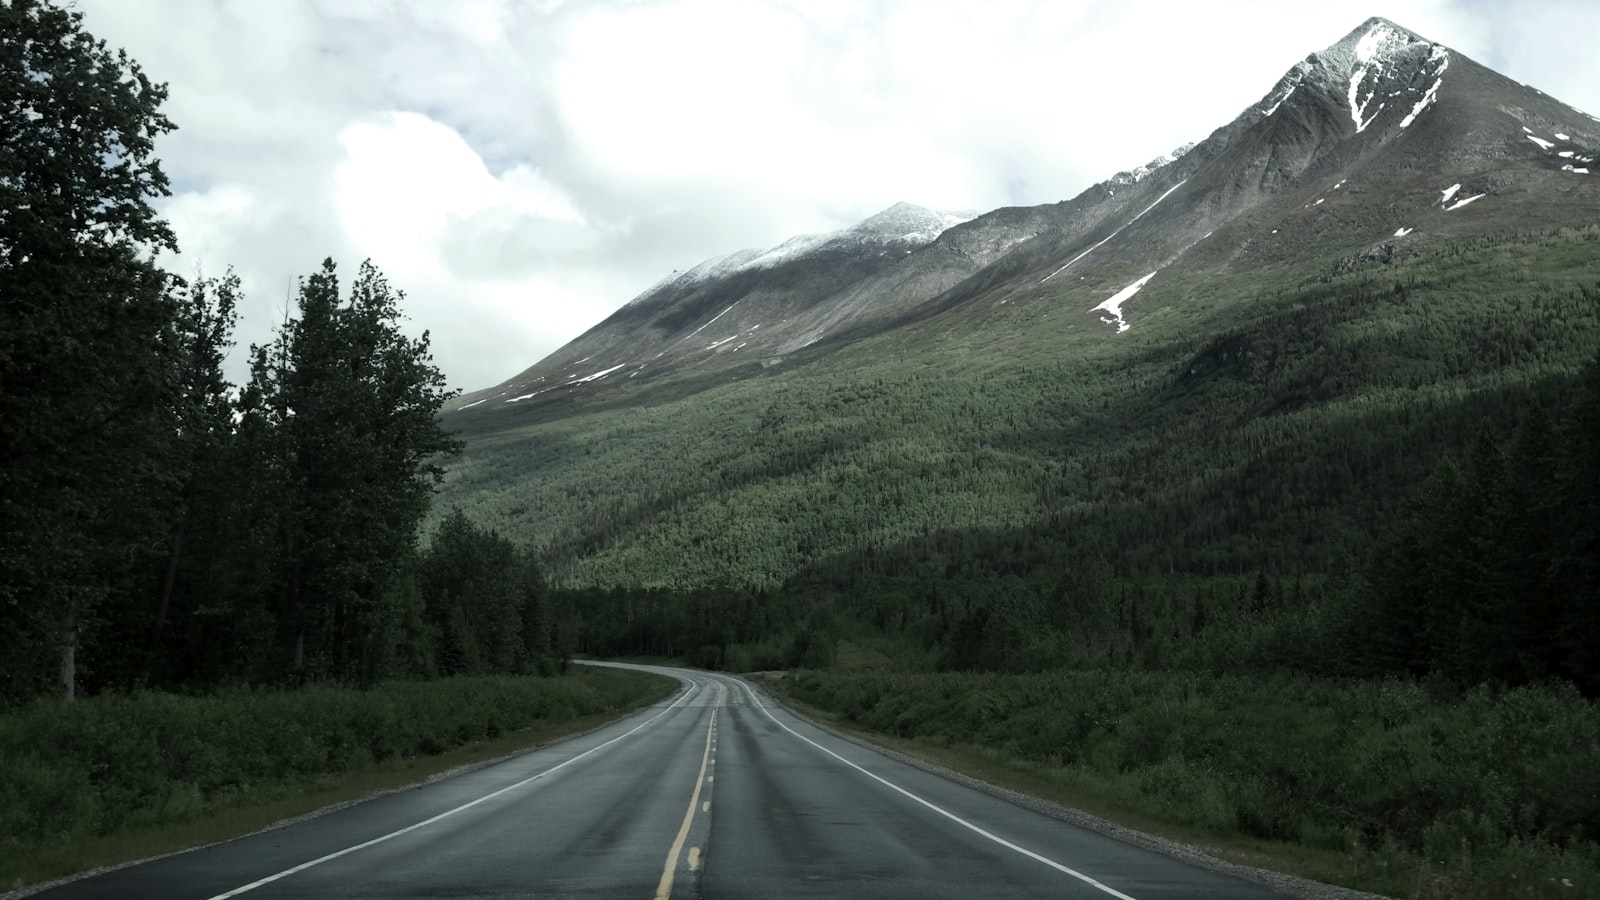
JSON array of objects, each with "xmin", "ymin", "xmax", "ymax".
[{"xmin": 28, "ymin": 666, "xmax": 1282, "ymax": 900}]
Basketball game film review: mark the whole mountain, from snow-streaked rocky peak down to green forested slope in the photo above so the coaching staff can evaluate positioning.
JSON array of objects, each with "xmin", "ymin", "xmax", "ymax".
[{"xmin": 443, "ymin": 19, "xmax": 1600, "ymax": 585}]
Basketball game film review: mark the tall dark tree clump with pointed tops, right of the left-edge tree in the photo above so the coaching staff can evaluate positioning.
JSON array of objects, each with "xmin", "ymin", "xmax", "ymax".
[{"xmin": 242, "ymin": 259, "xmax": 459, "ymax": 681}]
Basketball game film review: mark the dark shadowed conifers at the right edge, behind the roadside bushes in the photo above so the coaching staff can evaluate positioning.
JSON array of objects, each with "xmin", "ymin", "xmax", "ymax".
[{"xmin": 1350, "ymin": 357, "xmax": 1600, "ymax": 693}]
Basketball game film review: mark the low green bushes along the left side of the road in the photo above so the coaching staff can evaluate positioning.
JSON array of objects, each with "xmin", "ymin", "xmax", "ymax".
[{"xmin": 0, "ymin": 669, "xmax": 672, "ymax": 858}]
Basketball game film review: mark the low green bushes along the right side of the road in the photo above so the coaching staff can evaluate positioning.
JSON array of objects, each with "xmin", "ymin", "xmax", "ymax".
[{"xmin": 779, "ymin": 671, "xmax": 1600, "ymax": 897}]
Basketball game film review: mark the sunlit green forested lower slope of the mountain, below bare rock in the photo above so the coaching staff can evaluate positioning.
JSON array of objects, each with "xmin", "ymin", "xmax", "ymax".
[{"xmin": 442, "ymin": 229, "xmax": 1600, "ymax": 596}]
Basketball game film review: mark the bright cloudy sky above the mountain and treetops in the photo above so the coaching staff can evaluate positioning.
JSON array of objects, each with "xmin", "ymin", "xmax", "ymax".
[{"xmin": 77, "ymin": 0, "xmax": 1600, "ymax": 391}]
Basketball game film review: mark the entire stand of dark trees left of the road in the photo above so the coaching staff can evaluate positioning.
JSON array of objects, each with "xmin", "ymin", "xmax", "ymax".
[{"xmin": 0, "ymin": 0, "xmax": 563, "ymax": 701}]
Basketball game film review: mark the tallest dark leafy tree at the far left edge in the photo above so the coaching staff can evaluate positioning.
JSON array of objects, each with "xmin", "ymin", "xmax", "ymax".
[{"xmin": 0, "ymin": 0, "xmax": 174, "ymax": 697}]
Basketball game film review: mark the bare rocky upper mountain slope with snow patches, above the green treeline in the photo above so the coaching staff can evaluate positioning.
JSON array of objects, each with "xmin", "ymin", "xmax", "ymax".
[{"xmin": 458, "ymin": 19, "xmax": 1600, "ymax": 419}]
